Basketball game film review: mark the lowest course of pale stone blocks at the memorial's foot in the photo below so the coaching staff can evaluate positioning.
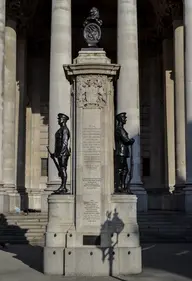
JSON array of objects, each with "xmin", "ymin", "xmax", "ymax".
[{"xmin": 44, "ymin": 247, "xmax": 142, "ymax": 277}]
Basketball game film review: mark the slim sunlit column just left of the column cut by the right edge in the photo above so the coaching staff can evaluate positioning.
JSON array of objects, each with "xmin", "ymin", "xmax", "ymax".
[{"xmin": 173, "ymin": 20, "xmax": 186, "ymax": 188}]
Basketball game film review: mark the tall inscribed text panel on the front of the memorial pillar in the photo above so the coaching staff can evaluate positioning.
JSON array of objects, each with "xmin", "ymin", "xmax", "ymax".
[{"xmin": 81, "ymin": 109, "xmax": 102, "ymax": 228}]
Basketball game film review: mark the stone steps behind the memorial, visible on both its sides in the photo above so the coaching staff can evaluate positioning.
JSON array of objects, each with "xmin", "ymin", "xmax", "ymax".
[{"xmin": 0, "ymin": 212, "xmax": 192, "ymax": 245}]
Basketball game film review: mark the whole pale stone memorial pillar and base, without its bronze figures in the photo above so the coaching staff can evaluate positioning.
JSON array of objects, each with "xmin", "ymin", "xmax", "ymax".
[{"xmin": 44, "ymin": 50, "xmax": 141, "ymax": 276}]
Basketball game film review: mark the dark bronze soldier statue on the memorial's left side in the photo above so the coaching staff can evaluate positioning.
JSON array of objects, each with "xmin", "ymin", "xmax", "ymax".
[{"xmin": 49, "ymin": 113, "xmax": 71, "ymax": 194}]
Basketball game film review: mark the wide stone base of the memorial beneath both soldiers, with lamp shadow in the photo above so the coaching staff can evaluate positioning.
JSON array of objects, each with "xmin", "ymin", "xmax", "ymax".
[{"xmin": 44, "ymin": 195, "xmax": 142, "ymax": 276}]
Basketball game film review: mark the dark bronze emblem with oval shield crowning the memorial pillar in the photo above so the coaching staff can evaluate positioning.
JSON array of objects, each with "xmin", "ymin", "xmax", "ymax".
[{"xmin": 83, "ymin": 7, "xmax": 103, "ymax": 48}]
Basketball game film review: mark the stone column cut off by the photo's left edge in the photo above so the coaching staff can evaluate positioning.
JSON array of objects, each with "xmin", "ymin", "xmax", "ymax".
[{"xmin": 0, "ymin": 0, "xmax": 8, "ymax": 210}]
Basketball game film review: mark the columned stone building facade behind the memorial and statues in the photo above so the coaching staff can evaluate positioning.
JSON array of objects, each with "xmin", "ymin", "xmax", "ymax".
[{"xmin": 0, "ymin": 0, "xmax": 192, "ymax": 212}]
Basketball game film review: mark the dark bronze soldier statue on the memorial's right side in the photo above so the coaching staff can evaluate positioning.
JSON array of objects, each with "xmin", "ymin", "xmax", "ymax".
[{"xmin": 115, "ymin": 112, "xmax": 135, "ymax": 194}]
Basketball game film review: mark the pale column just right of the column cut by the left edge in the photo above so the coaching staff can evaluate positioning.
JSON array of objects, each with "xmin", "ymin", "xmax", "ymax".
[{"xmin": 3, "ymin": 20, "xmax": 20, "ymax": 208}]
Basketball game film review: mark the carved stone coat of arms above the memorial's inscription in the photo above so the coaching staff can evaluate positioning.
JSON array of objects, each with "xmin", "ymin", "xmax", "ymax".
[{"xmin": 77, "ymin": 75, "xmax": 108, "ymax": 109}]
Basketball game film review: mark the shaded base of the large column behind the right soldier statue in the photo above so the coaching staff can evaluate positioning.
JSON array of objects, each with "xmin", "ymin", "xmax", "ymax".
[{"xmin": 130, "ymin": 183, "xmax": 148, "ymax": 212}]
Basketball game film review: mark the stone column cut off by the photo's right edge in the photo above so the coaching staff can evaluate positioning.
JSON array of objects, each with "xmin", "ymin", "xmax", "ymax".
[{"xmin": 183, "ymin": 0, "xmax": 192, "ymax": 212}]
